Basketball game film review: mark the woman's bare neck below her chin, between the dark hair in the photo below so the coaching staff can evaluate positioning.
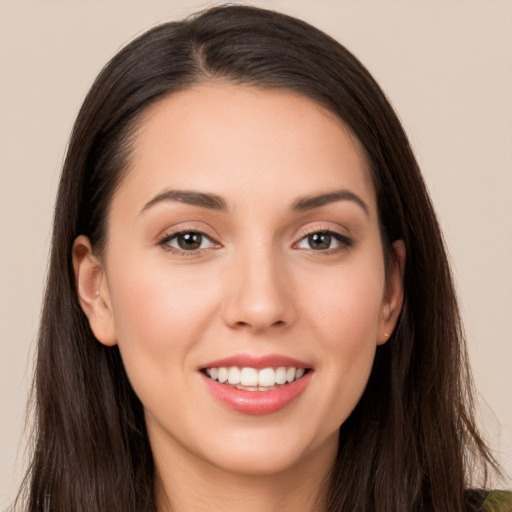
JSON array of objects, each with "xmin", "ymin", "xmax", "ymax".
[{"xmin": 155, "ymin": 432, "xmax": 337, "ymax": 512}]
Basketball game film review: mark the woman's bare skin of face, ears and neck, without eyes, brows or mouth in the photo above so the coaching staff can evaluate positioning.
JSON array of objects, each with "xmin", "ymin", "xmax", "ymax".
[{"xmin": 73, "ymin": 83, "xmax": 405, "ymax": 512}]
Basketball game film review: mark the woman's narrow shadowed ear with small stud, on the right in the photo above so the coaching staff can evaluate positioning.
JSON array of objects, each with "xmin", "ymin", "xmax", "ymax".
[{"xmin": 377, "ymin": 240, "xmax": 406, "ymax": 345}]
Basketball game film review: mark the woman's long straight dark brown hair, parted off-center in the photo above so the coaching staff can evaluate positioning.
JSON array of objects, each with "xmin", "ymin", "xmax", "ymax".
[{"xmin": 18, "ymin": 6, "xmax": 494, "ymax": 512}]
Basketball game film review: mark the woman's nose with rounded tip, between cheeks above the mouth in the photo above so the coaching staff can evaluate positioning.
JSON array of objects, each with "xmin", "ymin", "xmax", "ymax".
[{"xmin": 223, "ymin": 244, "xmax": 297, "ymax": 332}]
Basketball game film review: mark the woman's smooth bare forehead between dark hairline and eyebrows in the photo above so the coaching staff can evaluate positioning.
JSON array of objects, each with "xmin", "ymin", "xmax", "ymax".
[{"xmin": 114, "ymin": 83, "xmax": 374, "ymax": 212}]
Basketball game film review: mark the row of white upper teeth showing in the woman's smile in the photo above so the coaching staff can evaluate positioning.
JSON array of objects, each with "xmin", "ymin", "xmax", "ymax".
[{"xmin": 205, "ymin": 366, "xmax": 306, "ymax": 391}]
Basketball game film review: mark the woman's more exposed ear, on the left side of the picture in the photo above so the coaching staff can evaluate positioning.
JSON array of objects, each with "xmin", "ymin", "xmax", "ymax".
[{"xmin": 73, "ymin": 235, "xmax": 117, "ymax": 346}]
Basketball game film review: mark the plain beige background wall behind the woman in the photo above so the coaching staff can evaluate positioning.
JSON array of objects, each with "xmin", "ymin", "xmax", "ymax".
[{"xmin": 0, "ymin": 0, "xmax": 512, "ymax": 504}]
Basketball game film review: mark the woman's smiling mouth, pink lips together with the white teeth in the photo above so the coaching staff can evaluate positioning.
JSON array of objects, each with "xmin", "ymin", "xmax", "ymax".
[{"xmin": 199, "ymin": 355, "xmax": 313, "ymax": 415}]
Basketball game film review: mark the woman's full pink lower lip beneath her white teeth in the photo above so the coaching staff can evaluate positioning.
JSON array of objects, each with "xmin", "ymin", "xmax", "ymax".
[{"xmin": 201, "ymin": 371, "xmax": 313, "ymax": 415}]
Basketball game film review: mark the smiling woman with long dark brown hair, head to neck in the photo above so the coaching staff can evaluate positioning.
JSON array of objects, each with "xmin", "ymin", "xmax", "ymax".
[{"xmin": 13, "ymin": 7, "xmax": 508, "ymax": 512}]
